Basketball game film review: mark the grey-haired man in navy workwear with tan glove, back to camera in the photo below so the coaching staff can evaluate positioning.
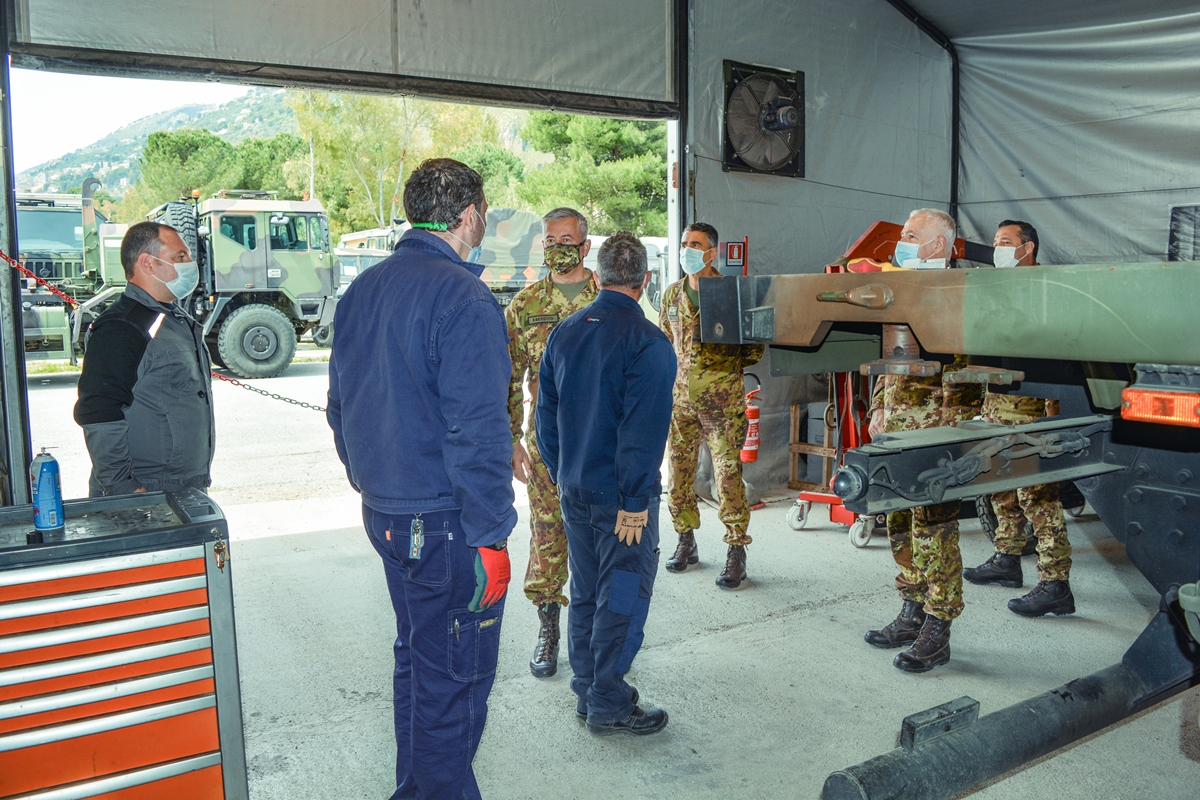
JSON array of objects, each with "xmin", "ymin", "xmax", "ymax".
[{"xmin": 535, "ymin": 230, "xmax": 676, "ymax": 734}]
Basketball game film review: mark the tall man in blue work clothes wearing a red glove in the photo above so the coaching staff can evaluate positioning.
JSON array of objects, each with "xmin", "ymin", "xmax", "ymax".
[{"xmin": 328, "ymin": 158, "xmax": 517, "ymax": 799}]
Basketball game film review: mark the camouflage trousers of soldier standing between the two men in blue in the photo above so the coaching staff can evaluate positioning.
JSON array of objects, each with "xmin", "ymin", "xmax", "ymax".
[{"xmin": 524, "ymin": 431, "xmax": 566, "ymax": 606}]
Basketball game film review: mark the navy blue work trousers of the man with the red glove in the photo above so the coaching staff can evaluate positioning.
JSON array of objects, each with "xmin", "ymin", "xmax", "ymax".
[{"xmin": 362, "ymin": 506, "xmax": 504, "ymax": 800}]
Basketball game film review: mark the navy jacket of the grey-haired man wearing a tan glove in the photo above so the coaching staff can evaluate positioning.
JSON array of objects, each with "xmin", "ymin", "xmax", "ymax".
[{"xmin": 534, "ymin": 289, "xmax": 676, "ymax": 511}]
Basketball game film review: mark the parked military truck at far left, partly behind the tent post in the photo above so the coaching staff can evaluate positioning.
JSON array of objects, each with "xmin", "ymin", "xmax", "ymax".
[{"xmin": 17, "ymin": 178, "xmax": 128, "ymax": 363}]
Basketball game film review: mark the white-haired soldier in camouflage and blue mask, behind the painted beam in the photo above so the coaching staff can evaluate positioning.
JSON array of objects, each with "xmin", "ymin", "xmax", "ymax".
[{"xmin": 864, "ymin": 209, "xmax": 983, "ymax": 673}]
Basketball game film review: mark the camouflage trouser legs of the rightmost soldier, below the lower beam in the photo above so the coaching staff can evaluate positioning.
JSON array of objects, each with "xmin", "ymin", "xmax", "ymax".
[{"xmin": 991, "ymin": 483, "xmax": 1070, "ymax": 581}]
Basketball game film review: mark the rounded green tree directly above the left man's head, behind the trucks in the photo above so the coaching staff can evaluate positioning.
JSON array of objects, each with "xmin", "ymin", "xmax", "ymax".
[{"xmin": 139, "ymin": 128, "xmax": 241, "ymax": 207}]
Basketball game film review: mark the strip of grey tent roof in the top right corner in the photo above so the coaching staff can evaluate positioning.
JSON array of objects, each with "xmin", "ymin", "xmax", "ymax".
[{"xmin": 907, "ymin": 0, "xmax": 1196, "ymax": 41}]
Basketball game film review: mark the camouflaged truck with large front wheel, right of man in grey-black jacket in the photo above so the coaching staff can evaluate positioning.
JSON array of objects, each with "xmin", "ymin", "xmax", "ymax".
[{"xmin": 148, "ymin": 190, "xmax": 337, "ymax": 378}]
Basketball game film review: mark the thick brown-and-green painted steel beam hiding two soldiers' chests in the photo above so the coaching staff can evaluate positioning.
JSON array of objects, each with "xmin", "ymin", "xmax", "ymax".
[{"xmin": 700, "ymin": 267, "xmax": 1200, "ymax": 366}]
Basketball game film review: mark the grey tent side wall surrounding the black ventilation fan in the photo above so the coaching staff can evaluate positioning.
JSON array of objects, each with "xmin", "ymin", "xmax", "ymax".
[{"xmin": 686, "ymin": 0, "xmax": 950, "ymax": 494}]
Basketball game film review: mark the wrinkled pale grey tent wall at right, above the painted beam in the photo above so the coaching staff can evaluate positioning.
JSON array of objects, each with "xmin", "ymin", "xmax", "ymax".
[{"xmin": 954, "ymin": 12, "xmax": 1200, "ymax": 264}]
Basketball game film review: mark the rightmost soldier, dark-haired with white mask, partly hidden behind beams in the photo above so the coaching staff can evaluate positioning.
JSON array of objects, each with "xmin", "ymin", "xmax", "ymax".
[{"xmin": 962, "ymin": 219, "xmax": 1075, "ymax": 616}]
